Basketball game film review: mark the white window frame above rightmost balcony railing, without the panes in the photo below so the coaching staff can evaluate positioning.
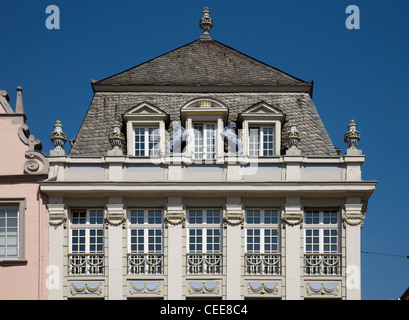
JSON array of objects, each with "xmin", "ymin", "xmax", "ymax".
[{"xmin": 303, "ymin": 209, "xmax": 342, "ymax": 254}]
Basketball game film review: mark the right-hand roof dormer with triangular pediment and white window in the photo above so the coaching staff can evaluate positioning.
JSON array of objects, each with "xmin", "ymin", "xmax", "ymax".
[{"xmin": 240, "ymin": 102, "xmax": 284, "ymax": 157}]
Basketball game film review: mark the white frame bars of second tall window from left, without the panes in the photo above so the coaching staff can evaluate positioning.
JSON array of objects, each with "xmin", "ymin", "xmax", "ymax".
[{"xmin": 128, "ymin": 208, "xmax": 164, "ymax": 254}]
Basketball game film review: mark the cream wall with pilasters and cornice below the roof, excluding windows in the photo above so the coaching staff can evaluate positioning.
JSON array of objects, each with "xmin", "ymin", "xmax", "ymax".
[{"xmin": 41, "ymin": 146, "xmax": 374, "ymax": 300}]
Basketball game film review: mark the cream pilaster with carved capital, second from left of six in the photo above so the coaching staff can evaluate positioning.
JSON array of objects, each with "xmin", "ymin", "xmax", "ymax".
[{"xmin": 105, "ymin": 198, "xmax": 126, "ymax": 300}]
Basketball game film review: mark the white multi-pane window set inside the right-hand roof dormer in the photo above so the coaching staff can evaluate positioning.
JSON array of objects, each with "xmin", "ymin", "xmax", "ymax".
[{"xmin": 249, "ymin": 126, "xmax": 274, "ymax": 157}]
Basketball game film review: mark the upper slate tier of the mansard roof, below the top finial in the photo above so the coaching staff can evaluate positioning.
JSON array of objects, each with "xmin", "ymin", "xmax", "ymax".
[{"xmin": 94, "ymin": 40, "xmax": 309, "ymax": 87}]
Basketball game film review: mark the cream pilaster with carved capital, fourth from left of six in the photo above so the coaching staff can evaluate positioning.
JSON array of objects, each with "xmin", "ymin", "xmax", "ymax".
[{"xmin": 224, "ymin": 197, "xmax": 244, "ymax": 300}]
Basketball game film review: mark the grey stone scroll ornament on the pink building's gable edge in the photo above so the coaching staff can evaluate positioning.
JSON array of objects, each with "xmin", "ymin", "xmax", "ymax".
[{"xmin": 18, "ymin": 124, "xmax": 50, "ymax": 175}]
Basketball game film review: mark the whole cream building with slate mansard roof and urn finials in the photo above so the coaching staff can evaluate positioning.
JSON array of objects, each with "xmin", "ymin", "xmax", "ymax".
[{"xmin": 41, "ymin": 8, "xmax": 376, "ymax": 300}]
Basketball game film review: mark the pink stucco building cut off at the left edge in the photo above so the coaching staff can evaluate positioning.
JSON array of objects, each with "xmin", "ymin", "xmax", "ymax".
[{"xmin": 0, "ymin": 87, "xmax": 49, "ymax": 300}]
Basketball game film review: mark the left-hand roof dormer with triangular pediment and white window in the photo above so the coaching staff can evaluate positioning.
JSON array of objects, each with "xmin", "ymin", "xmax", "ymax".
[{"xmin": 123, "ymin": 102, "xmax": 168, "ymax": 157}]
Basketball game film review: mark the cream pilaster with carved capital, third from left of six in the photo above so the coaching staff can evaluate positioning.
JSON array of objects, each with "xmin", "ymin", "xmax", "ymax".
[{"xmin": 165, "ymin": 197, "xmax": 186, "ymax": 300}]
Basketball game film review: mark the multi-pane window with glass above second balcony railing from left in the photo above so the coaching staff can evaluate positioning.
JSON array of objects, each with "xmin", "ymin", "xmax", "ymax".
[{"xmin": 129, "ymin": 209, "xmax": 163, "ymax": 253}]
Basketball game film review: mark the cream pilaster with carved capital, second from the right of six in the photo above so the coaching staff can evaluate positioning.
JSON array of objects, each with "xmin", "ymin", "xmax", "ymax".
[{"xmin": 282, "ymin": 197, "xmax": 303, "ymax": 300}]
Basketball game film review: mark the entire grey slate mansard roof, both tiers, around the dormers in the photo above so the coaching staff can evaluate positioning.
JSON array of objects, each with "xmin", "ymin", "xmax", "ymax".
[{"xmin": 70, "ymin": 40, "xmax": 337, "ymax": 157}]
